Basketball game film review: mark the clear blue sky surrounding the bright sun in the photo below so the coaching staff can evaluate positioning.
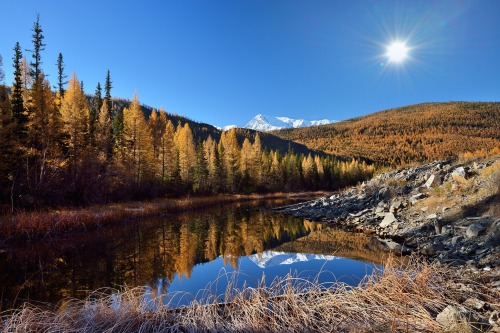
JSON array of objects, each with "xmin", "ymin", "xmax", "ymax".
[{"xmin": 0, "ymin": 0, "xmax": 500, "ymax": 126}]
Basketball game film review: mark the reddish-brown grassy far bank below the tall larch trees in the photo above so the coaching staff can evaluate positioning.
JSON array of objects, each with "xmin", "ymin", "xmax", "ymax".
[{"xmin": 0, "ymin": 192, "xmax": 325, "ymax": 241}]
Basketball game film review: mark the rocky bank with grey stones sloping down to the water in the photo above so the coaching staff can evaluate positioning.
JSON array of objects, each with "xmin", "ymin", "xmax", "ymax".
[{"xmin": 276, "ymin": 156, "xmax": 500, "ymax": 330}]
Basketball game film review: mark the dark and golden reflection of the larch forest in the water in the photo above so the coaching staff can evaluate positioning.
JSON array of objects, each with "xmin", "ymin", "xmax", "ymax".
[{"xmin": 0, "ymin": 197, "xmax": 322, "ymax": 310}]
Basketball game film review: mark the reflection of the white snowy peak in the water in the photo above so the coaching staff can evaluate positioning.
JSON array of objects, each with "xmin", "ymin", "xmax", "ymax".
[{"xmin": 248, "ymin": 251, "xmax": 338, "ymax": 268}]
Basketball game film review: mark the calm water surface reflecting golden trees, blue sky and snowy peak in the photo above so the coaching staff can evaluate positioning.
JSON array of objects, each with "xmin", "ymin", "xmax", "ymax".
[{"xmin": 0, "ymin": 197, "xmax": 382, "ymax": 310}]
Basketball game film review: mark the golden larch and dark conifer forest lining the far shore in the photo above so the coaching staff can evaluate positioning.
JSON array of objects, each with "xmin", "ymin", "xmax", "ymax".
[{"xmin": 0, "ymin": 18, "xmax": 374, "ymax": 210}]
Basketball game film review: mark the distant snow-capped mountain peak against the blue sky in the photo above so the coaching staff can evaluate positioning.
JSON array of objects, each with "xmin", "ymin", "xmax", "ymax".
[{"xmin": 244, "ymin": 114, "xmax": 335, "ymax": 131}]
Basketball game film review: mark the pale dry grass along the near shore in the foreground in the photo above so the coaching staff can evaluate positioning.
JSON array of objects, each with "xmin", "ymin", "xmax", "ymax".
[{"xmin": 0, "ymin": 255, "xmax": 499, "ymax": 332}]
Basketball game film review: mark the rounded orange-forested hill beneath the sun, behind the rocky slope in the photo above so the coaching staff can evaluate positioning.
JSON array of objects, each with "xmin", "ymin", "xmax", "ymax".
[{"xmin": 272, "ymin": 102, "xmax": 500, "ymax": 166}]
